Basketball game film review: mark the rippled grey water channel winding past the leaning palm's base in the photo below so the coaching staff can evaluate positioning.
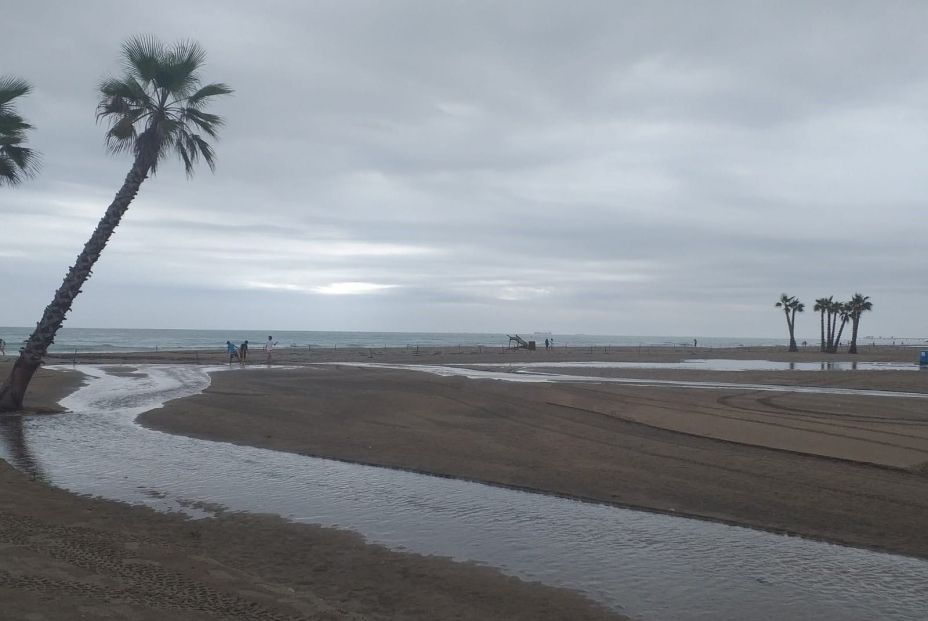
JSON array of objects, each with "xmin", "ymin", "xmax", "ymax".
[{"xmin": 0, "ymin": 365, "xmax": 928, "ymax": 621}]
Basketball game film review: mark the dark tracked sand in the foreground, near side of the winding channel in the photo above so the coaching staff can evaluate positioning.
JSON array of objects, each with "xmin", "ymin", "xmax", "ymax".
[{"xmin": 0, "ymin": 363, "xmax": 621, "ymax": 621}]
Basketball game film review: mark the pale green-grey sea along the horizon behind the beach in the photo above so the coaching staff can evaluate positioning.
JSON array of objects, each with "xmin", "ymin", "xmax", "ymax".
[{"xmin": 0, "ymin": 327, "xmax": 926, "ymax": 356}]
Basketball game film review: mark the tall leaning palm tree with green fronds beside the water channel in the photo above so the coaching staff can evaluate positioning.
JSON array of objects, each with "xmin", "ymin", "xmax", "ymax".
[{"xmin": 0, "ymin": 37, "xmax": 232, "ymax": 411}]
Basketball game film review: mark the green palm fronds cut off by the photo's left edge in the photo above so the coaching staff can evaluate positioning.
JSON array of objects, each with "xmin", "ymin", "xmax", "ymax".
[{"xmin": 0, "ymin": 77, "xmax": 39, "ymax": 186}]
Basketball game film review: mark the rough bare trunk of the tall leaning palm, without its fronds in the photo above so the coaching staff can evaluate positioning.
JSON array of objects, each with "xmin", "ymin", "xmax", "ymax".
[{"xmin": 0, "ymin": 151, "xmax": 157, "ymax": 412}]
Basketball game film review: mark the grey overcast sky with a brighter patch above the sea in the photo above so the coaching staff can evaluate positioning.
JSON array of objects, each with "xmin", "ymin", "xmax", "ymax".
[{"xmin": 0, "ymin": 0, "xmax": 928, "ymax": 338}]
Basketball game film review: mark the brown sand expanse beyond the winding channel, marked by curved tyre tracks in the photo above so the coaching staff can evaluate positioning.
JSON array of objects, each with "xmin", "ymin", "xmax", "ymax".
[{"xmin": 132, "ymin": 348, "xmax": 928, "ymax": 558}]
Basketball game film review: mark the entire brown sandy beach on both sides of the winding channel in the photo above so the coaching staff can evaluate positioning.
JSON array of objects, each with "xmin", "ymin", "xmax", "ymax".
[{"xmin": 0, "ymin": 348, "xmax": 928, "ymax": 619}]
